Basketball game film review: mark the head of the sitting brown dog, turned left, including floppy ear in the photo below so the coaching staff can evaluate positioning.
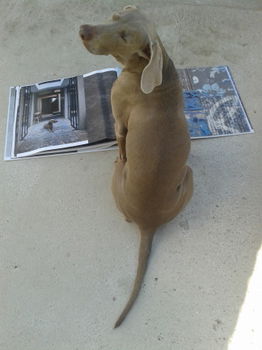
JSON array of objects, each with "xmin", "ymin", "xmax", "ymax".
[{"xmin": 79, "ymin": 6, "xmax": 163, "ymax": 94}]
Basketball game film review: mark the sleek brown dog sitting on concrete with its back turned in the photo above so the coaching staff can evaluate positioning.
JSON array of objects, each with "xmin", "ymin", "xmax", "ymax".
[{"xmin": 80, "ymin": 6, "xmax": 193, "ymax": 327}]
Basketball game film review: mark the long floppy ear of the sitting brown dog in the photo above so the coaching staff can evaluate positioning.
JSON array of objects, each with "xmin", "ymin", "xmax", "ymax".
[{"xmin": 140, "ymin": 36, "xmax": 163, "ymax": 94}]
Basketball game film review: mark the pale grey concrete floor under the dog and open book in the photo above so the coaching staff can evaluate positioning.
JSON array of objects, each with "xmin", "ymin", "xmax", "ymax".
[{"xmin": 0, "ymin": 0, "xmax": 262, "ymax": 350}]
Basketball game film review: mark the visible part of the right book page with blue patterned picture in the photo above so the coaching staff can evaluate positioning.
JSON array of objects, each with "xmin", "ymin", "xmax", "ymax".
[{"xmin": 178, "ymin": 66, "xmax": 253, "ymax": 139}]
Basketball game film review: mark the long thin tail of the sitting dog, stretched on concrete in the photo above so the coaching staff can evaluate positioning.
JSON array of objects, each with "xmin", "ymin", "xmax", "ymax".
[{"xmin": 114, "ymin": 230, "xmax": 155, "ymax": 328}]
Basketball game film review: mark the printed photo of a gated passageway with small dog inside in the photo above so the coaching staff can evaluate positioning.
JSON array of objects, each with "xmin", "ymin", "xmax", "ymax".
[{"xmin": 15, "ymin": 76, "xmax": 88, "ymax": 153}]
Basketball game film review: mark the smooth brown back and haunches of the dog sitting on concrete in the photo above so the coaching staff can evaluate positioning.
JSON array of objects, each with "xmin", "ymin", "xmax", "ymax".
[{"xmin": 112, "ymin": 56, "xmax": 192, "ymax": 228}]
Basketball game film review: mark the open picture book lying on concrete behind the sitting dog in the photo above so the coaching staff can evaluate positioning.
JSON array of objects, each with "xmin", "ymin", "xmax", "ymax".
[{"xmin": 4, "ymin": 66, "xmax": 253, "ymax": 160}]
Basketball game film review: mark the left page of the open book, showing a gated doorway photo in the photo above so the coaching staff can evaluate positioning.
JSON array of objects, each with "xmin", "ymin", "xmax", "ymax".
[{"xmin": 5, "ymin": 68, "xmax": 118, "ymax": 159}]
